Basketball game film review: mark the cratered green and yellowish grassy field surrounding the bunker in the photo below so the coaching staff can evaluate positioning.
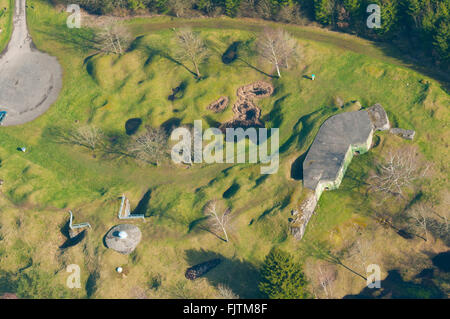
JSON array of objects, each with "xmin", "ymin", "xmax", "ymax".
[{"xmin": 0, "ymin": 0, "xmax": 450, "ymax": 298}]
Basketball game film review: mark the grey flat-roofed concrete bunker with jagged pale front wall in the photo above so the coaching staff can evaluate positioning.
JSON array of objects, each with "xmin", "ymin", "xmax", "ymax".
[{"xmin": 291, "ymin": 104, "xmax": 390, "ymax": 239}]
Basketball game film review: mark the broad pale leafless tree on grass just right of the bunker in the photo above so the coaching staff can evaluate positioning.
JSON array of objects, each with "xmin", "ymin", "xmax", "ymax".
[{"xmin": 369, "ymin": 147, "xmax": 429, "ymax": 197}]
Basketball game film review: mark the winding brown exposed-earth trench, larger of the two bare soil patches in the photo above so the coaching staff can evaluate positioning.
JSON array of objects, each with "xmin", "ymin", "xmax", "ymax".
[{"xmin": 220, "ymin": 81, "xmax": 274, "ymax": 131}]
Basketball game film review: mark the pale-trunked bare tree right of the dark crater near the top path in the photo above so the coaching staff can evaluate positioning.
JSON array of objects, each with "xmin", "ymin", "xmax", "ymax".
[{"xmin": 257, "ymin": 28, "xmax": 298, "ymax": 77}]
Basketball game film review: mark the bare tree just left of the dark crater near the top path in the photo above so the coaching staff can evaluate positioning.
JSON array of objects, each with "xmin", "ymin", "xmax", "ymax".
[{"xmin": 174, "ymin": 29, "xmax": 208, "ymax": 78}]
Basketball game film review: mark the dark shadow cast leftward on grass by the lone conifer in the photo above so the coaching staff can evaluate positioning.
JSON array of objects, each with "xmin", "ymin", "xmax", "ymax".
[{"xmin": 185, "ymin": 249, "xmax": 263, "ymax": 299}]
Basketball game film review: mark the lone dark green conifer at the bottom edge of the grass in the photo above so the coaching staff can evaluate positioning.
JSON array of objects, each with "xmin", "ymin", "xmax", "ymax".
[{"xmin": 259, "ymin": 248, "xmax": 310, "ymax": 299}]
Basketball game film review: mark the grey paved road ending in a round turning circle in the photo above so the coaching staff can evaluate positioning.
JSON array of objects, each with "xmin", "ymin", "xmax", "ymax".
[{"xmin": 0, "ymin": 0, "xmax": 62, "ymax": 126}]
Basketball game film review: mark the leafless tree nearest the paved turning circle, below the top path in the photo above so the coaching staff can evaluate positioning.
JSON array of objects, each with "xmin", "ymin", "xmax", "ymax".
[{"xmin": 96, "ymin": 19, "xmax": 131, "ymax": 55}]
